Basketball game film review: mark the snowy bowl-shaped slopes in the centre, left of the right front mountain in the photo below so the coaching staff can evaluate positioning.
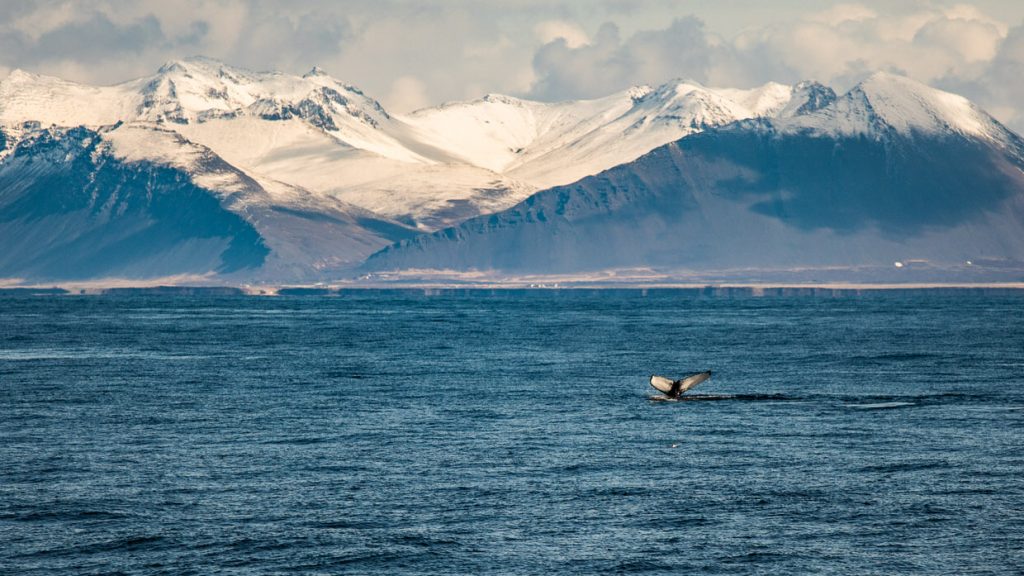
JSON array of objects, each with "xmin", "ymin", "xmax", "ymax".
[{"xmin": 406, "ymin": 80, "xmax": 792, "ymax": 188}]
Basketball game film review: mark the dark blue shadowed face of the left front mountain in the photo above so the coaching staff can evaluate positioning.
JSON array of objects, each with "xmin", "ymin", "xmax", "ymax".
[{"xmin": 0, "ymin": 124, "xmax": 268, "ymax": 279}]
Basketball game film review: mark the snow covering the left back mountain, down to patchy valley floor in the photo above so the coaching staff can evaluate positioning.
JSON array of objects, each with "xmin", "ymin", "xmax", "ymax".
[{"xmin": 0, "ymin": 57, "xmax": 499, "ymax": 225}]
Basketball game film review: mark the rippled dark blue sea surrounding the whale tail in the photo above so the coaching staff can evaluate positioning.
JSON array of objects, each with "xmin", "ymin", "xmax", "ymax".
[{"xmin": 0, "ymin": 292, "xmax": 1024, "ymax": 574}]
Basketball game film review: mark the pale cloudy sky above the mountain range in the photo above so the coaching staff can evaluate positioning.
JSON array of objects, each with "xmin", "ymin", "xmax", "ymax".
[{"xmin": 6, "ymin": 0, "xmax": 1024, "ymax": 131}]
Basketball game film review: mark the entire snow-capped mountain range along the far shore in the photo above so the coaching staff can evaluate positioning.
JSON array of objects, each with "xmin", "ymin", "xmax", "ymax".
[{"xmin": 0, "ymin": 57, "xmax": 1024, "ymax": 282}]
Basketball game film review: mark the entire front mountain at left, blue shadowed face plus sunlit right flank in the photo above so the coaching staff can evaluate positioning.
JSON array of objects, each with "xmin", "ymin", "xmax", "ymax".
[{"xmin": 0, "ymin": 124, "xmax": 412, "ymax": 281}]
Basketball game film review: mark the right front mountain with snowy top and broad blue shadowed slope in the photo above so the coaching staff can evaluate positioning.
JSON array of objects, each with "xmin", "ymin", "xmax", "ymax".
[{"xmin": 367, "ymin": 74, "xmax": 1024, "ymax": 281}]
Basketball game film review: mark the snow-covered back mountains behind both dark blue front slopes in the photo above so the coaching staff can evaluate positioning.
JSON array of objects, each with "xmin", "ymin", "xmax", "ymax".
[{"xmin": 0, "ymin": 57, "xmax": 792, "ymax": 231}]
